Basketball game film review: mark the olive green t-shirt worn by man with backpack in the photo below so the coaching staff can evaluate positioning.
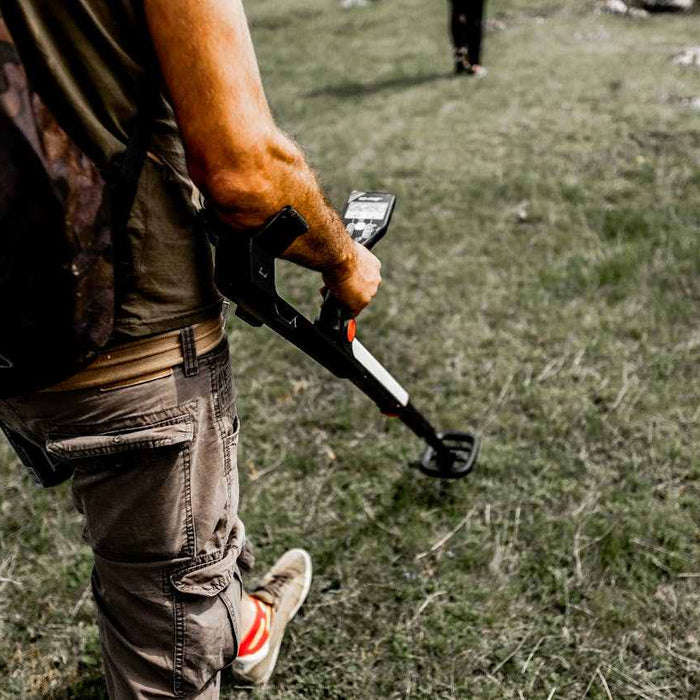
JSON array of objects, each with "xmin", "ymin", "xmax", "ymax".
[{"xmin": 0, "ymin": 0, "xmax": 221, "ymax": 342}]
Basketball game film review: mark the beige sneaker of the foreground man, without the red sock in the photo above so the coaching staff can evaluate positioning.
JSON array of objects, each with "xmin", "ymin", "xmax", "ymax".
[{"xmin": 231, "ymin": 549, "xmax": 312, "ymax": 685}]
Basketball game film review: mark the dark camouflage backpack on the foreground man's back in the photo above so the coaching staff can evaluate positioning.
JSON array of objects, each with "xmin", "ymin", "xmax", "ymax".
[{"xmin": 0, "ymin": 16, "xmax": 150, "ymax": 398}]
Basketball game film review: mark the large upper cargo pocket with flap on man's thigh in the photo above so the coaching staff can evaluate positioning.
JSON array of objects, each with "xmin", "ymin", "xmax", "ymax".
[{"xmin": 46, "ymin": 406, "xmax": 196, "ymax": 561}]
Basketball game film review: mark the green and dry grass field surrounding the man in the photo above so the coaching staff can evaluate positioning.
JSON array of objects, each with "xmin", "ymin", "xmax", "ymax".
[{"xmin": 0, "ymin": 0, "xmax": 700, "ymax": 700}]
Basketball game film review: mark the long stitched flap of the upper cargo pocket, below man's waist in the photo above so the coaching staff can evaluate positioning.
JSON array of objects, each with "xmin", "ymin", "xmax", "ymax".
[{"xmin": 46, "ymin": 416, "xmax": 194, "ymax": 459}]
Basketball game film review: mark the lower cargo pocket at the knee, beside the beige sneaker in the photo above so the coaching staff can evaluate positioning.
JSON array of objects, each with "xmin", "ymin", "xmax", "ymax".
[{"xmin": 170, "ymin": 547, "xmax": 243, "ymax": 696}]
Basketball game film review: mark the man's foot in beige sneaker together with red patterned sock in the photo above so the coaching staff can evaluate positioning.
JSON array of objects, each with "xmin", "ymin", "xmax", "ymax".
[{"xmin": 231, "ymin": 549, "xmax": 311, "ymax": 686}]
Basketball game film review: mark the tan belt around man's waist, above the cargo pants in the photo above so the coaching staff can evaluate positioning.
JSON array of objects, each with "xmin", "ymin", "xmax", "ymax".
[{"xmin": 44, "ymin": 317, "xmax": 224, "ymax": 391}]
